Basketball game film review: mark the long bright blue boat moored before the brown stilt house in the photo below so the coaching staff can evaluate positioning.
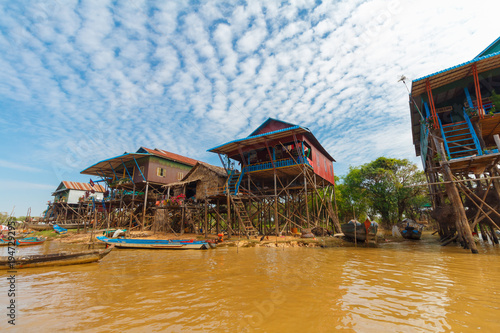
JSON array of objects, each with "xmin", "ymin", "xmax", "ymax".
[{"xmin": 97, "ymin": 236, "xmax": 216, "ymax": 250}]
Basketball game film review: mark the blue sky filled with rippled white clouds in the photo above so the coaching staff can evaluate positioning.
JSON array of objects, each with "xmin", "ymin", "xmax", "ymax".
[{"xmin": 0, "ymin": 0, "xmax": 500, "ymax": 216}]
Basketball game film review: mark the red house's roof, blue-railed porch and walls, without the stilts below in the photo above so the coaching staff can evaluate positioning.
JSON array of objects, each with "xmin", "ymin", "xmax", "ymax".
[{"xmin": 209, "ymin": 118, "xmax": 335, "ymax": 194}]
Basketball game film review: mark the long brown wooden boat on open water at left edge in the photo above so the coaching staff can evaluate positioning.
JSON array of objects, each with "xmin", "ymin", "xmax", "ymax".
[{"xmin": 0, "ymin": 247, "xmax": 113, "ymax": 269}]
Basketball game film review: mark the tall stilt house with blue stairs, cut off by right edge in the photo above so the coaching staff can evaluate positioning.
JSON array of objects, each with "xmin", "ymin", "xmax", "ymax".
[{"xmin": 410, "ymin": 38, "xmax": 500, "ymax": 253}]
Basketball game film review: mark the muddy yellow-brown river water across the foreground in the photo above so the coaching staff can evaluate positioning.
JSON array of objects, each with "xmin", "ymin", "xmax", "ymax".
[{"xmin": 0, "ymin": 235, "xmax": 500, "ymax": 332}]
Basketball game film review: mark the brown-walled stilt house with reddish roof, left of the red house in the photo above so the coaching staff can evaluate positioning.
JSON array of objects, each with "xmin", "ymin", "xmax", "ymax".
[{"xmin": 77, "ymin": 147, "xmax": 198, "ymax": 229}]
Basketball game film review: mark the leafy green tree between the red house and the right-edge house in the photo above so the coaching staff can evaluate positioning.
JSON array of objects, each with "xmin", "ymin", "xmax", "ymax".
[{"xmin": 336, "ymin": 157, "xmax": 428, "ymax": 226}]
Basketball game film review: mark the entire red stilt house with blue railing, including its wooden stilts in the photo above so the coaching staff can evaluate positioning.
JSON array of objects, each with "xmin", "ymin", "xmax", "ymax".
[{"xmin": 209, "ymin": 118, "xmax": 340, "ymax": 236}]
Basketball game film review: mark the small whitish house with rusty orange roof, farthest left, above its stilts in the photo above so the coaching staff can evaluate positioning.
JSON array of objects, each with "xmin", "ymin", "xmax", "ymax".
[{"xmin": 52, "ymin": 181, "xmax": 106, "ymax": 205}]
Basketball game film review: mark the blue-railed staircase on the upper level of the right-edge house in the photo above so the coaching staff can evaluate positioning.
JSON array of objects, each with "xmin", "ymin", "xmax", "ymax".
[{"xmin": 441, "ymin": 116, "xmax": 482, "ymax": 159}]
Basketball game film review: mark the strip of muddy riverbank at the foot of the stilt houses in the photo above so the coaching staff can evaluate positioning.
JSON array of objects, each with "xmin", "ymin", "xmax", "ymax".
[{"xmin": 26, "ymin": 230, "xmax": 403, "ymax": 248}]
